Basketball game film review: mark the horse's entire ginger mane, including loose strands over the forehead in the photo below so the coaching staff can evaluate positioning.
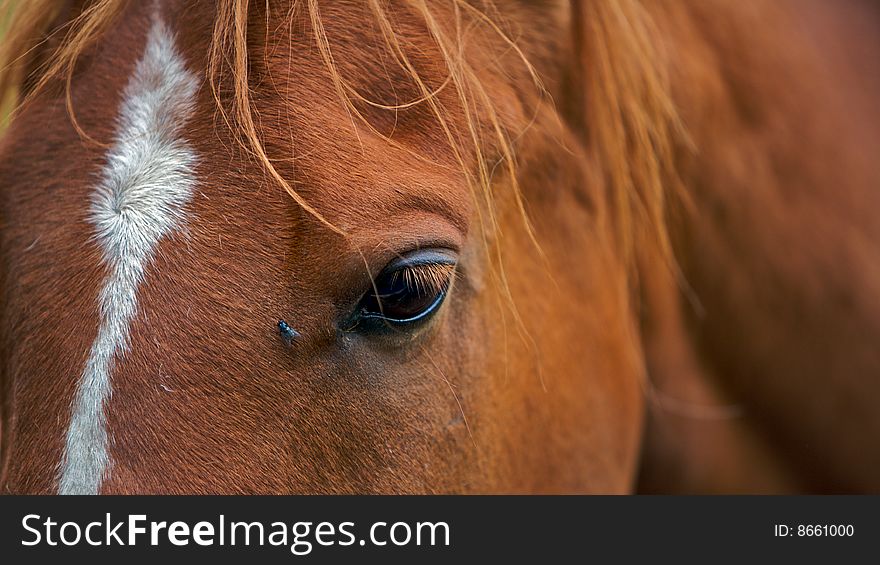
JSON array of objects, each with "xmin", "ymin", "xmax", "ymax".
[{"xmin": 0, "ymin": 0, "xmax": 686, "ymax": 262}]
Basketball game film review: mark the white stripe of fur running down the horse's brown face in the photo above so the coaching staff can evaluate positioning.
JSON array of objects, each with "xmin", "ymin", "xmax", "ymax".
[{"xmin": 58, "ymin": 16, "xmax": 198, "ymax": 494}]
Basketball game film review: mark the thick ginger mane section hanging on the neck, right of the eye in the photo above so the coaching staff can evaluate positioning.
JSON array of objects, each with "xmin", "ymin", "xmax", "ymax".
[{"xmin": 571, "ymin": 0, "xmax": 693, "ymax": 270}]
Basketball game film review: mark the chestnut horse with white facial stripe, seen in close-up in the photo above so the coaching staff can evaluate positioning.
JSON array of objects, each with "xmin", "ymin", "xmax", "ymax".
[{"xmin": 0, "ymin": 0, "xmax": 880, "ymax": 494}]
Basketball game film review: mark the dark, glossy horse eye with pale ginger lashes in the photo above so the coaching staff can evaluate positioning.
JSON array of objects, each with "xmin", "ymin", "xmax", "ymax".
[{"xmin": 356, "ymin": 250, "xmax": 455, "ymax": 330}]
